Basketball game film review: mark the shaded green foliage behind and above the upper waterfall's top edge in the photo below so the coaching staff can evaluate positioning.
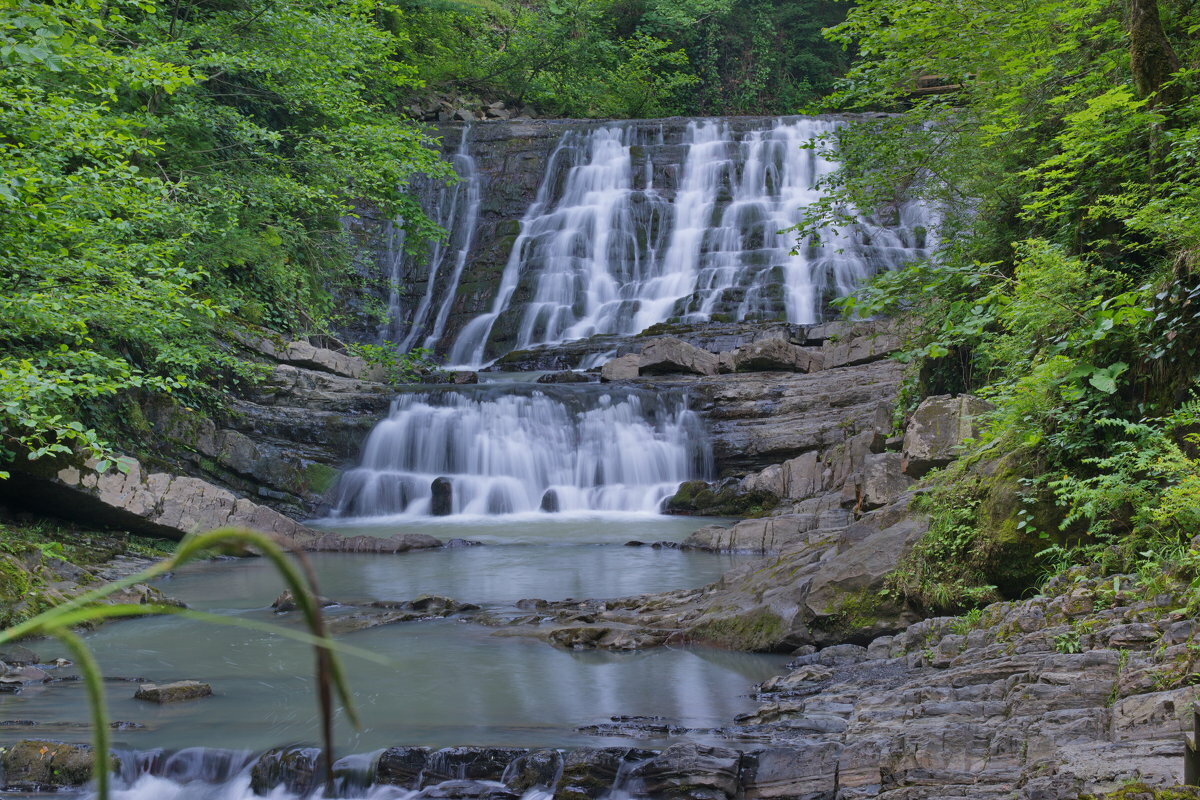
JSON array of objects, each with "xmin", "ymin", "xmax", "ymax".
[{"xmin": 391, "ymin": 0, "xmax": 845, "ymax": 118}]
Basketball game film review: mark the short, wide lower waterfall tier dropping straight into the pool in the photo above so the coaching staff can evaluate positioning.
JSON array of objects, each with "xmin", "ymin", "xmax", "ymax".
[{"xmin": 335, "ymin": 384, "xmax": 710, "ymax": 517}]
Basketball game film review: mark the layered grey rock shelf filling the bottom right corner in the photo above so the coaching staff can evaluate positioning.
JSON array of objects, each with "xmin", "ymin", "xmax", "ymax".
[{"xmin": 720, "ymin": 563, "xmax": 1200, "ymax": 800}]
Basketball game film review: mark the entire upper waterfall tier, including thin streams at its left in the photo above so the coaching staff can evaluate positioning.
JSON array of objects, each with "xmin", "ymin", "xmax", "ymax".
[{"xmin": 369, "ymin": 118, "xmax": 929, "ymax": 365}]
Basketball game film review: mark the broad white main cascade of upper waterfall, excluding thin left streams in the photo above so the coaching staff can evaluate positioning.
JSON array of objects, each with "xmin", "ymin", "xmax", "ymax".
[{"xmin": 436, "ymin": 118, "xmax": 930, "ymax": 365}]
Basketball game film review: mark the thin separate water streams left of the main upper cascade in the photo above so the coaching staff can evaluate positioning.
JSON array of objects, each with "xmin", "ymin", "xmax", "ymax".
[{"xmin": 379, "ymin": 125, "xmax": 481, "ymax": 351}]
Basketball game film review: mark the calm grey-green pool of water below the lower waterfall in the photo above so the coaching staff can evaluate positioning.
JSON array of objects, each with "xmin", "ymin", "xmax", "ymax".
[{"xmin": 0, "ymin": 517, "xmax": 785, "ymax": 752}]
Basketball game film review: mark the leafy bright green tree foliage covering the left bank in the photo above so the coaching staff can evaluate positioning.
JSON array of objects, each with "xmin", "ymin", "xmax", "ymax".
[{"xmin": 0, "ymin": 0, "xmax": 445, "ymax": 474}]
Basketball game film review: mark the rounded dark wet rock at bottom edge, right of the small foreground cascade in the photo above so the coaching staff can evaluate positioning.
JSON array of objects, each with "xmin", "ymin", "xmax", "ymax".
[{"xmin": 632, "ymin": 742, "xmax": 742, "ymax": 800}]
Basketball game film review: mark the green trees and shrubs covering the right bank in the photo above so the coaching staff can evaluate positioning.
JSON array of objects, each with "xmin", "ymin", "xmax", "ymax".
[{"xmin": 820, "ymin": 0, "xmax": 1200, "ymax": 594}]
